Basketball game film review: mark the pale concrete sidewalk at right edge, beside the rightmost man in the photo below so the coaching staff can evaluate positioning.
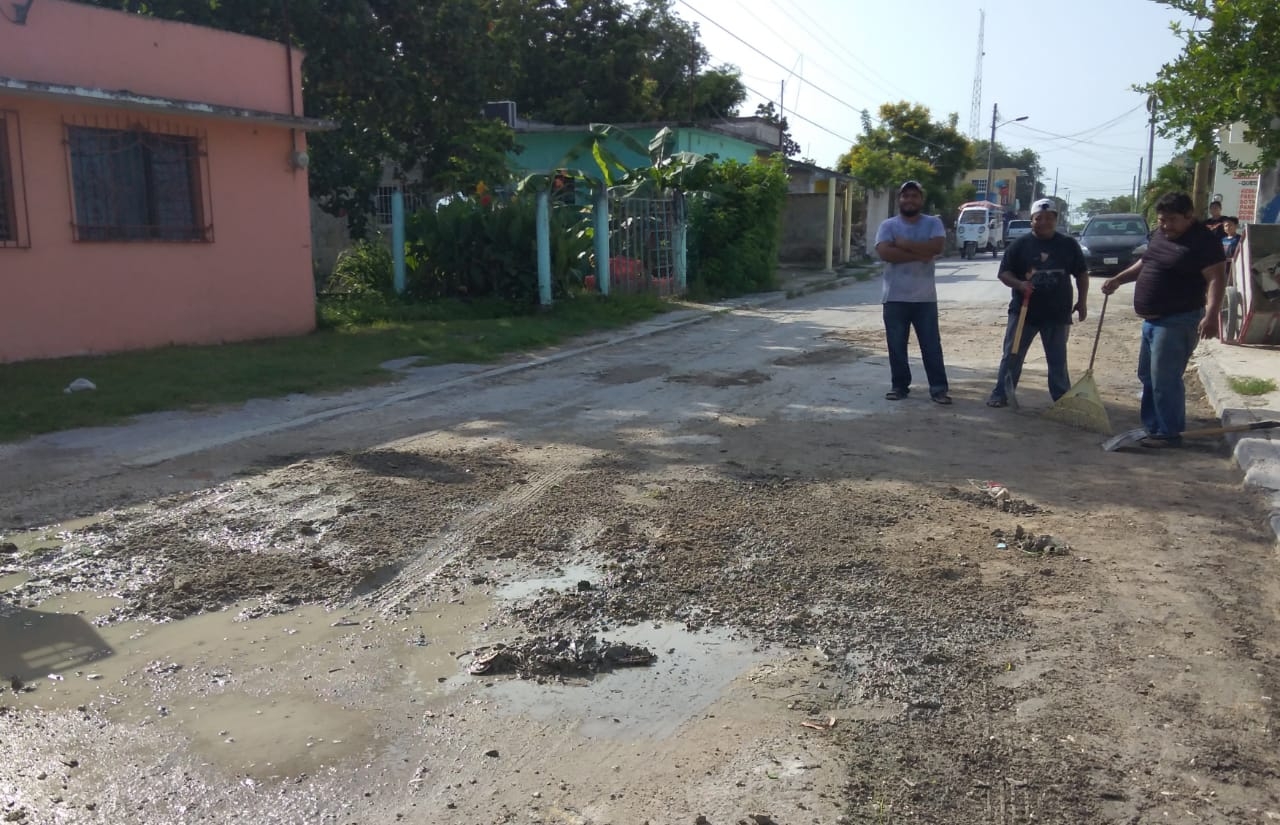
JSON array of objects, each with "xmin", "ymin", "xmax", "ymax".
[{"xmin": 1193, "ymin": 340, "xmax": 1280, "ymax": 538}]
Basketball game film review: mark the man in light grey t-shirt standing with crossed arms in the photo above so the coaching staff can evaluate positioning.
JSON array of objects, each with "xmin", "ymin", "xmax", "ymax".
[{"xmin": 876, "ymin": 180, "xmax": 951, "ymax": 404}]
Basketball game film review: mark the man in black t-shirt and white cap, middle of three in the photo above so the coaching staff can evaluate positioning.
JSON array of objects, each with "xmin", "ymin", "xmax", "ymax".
[{"xmin": 987, "ymin": 198, "xmax": 1089, "ymax": 407}]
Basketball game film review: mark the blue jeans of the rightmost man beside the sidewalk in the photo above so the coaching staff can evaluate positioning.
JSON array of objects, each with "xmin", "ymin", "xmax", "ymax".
[{"xmin": 1138, "ymin": 310, "xmax": 1204, "ymax": 439}]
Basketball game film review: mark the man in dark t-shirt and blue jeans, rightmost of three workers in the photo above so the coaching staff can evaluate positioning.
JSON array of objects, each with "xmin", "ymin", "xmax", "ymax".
[{"xmin": 1102, "ymin": 192, "xmax": 1226, "ymax": 448}]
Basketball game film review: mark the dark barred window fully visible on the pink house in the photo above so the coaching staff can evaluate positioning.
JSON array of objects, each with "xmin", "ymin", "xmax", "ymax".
[{"xmin": 67, "ymin": 125, "xmax": 210, "ymax": 240}]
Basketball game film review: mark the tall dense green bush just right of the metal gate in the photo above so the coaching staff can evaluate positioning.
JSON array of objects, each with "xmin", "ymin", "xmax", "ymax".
[{"xmin": 689, "ymin": 155, "xmax": 787, "ymax": 298}]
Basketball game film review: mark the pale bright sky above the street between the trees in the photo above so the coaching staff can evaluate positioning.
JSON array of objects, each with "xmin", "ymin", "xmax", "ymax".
[{"xmin": 675, "ymin": 0, "xmax": 1190, "ymax": 216}]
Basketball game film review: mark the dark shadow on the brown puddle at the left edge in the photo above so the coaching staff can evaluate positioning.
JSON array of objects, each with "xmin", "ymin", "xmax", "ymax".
[{"xmin": 0, "ymin": 600, "xmax": 115, "ymax": 687}]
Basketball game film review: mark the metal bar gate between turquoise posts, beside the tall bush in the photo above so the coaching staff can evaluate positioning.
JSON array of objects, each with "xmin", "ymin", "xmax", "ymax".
[{"xmin": 609, "ymin": 192, "xmax": 689, "ymax": 295}]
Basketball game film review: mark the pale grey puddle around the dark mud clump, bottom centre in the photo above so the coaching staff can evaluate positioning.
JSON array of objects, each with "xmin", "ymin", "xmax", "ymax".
[{"xmin": 493, "ymin": 624, "xmax": 767, "ymax": 739}]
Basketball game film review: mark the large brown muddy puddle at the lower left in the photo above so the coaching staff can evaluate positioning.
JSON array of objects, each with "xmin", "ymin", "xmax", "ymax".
[{"xmin": 0, "ymin": 585, "xmax": 493, "ymax": 782}]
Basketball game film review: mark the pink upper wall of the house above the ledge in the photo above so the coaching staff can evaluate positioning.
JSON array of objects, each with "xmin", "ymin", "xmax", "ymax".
[{"xmin": 0, "ymin": 0, "xmax": 302, "ymax": 114}]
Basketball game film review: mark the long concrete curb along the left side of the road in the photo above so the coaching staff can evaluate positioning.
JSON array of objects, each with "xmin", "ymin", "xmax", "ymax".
[{"xmin": 123, "ymin": 275, "xmax": 858, "ymax": 469}]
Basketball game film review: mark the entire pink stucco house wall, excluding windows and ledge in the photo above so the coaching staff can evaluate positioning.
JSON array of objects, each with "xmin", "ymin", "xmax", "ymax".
[{"xmin": 0, "ymin": 0, "xmax": 315, "ymax": 361}]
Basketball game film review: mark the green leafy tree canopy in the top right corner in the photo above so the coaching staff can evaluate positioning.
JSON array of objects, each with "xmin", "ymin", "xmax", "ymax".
[{"xmin": 1138, "ymin": 0, "xmax": 1280, "ymax": 165}]
